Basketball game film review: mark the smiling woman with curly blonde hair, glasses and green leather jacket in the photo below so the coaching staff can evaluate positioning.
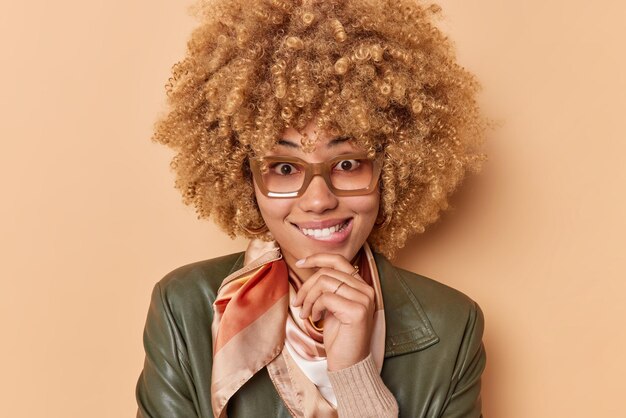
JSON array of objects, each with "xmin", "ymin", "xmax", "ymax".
[{"xmin": 137, "ymin": 0, "xmax": 485, "ymax": 418}]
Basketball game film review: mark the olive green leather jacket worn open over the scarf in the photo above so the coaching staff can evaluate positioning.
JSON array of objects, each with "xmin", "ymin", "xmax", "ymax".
[{"xmin": 136, "ymin": 253, "xmax": 485, "ymax": 418}]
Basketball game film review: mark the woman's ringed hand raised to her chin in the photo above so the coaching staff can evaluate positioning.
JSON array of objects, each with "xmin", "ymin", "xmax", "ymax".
[{"xmin": 294, "ymin": 253, "xmax": 375, "ymax": 371}]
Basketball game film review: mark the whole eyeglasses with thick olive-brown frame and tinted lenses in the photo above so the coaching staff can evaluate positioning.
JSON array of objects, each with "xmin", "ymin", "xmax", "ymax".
[{"xmin": 250, "ymin": 153, "xmax": 382, "ymax": 198}]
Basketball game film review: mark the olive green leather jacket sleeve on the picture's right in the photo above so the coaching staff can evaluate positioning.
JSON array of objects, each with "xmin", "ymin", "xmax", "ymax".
[{"xmin": 441, "ymin": 303, "xmax": 486, "ymax": 418}]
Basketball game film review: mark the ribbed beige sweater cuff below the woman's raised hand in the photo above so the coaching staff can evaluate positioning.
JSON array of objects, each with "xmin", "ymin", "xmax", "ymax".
[{"xmin": 328, "ymin": 354, "xmax": 398, "ymax": 417}]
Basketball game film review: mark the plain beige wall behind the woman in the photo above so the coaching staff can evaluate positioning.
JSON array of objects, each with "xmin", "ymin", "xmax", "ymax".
[{"xmin": 0, "ymin": 0, "xmax": 626, "ymax": 418}]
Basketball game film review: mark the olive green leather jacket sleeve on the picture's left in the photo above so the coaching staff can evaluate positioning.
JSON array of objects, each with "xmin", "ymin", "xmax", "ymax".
[{"xmin": 135, "ymin": 283, "xmax": 198, "ymax": 418}]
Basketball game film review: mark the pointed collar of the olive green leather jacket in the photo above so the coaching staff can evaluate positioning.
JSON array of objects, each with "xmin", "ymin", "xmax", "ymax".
[{"xmin": 224, "ymin": 248, "xmax": 439, "ymax": 358}]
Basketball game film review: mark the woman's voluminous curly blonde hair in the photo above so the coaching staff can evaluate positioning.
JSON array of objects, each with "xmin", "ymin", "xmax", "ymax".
[{"xmin": 153, "ymin": 0, "xmax": 486, "ymax": 257}]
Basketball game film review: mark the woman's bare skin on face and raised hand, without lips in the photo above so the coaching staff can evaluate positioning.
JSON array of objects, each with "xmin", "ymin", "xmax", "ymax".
[{"xmin": 255, "ymin": 121, "xmax": 380, "ymax": 371}]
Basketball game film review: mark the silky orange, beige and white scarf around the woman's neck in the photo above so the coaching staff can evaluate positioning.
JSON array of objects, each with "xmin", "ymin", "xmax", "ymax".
[{"xmin": 211, "ymin": 240, "xmax": 385, "ymax": 418}]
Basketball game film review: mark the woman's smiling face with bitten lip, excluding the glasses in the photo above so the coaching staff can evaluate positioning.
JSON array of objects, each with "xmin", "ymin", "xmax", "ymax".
[{"xmin": 255, "ymin": 122, "xmax": 380, "ymax": 268}]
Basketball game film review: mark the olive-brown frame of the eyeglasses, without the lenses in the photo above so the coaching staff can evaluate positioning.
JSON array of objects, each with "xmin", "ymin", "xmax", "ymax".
[{"xmin": 250, "ymin": 152, "xmax": 382, "ymax": 199}]
